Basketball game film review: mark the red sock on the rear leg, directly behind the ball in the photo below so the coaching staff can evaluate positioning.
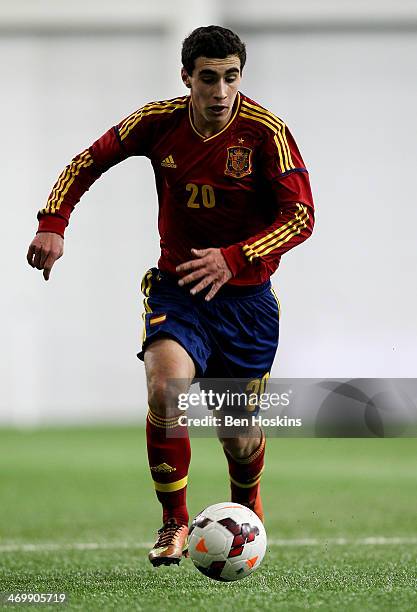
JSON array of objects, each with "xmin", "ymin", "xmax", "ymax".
[{"xmin": 224, "ymin": 433, "xmax": 265, "ymax": 520}]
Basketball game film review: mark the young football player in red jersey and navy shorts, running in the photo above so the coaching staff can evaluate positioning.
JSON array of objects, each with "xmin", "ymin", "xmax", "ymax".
[{"xmin": 27, "ymin": 26, "xmax": 314, "ymax": 565}]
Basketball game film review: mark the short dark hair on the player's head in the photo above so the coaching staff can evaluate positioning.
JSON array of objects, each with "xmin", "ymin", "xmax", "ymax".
[{"xmin": 181, "ymin": 26, "xmax": 246, "ymax": 76}]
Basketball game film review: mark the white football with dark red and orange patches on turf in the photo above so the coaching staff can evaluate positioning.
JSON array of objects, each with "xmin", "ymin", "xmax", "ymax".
[{"xmin": 188, "ymin": 502, "xmax": 266, "ymax": 582}]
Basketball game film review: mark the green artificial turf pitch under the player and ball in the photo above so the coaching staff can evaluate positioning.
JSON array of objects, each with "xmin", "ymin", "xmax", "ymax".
[{"xmin": 0, "ymin": 427, "xmax": 417, "ymax": 612}]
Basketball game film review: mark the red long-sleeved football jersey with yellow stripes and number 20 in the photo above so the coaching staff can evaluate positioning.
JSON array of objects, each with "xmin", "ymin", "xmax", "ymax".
[{"xmin": 38, "ymin": 94, "xmax": 314, "ymax": 285}]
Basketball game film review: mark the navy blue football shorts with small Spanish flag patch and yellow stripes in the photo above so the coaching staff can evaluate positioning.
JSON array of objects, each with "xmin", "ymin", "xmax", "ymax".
[{"xmin": 138, "ymin": 268, "xmax": 279, "ymax": 379}]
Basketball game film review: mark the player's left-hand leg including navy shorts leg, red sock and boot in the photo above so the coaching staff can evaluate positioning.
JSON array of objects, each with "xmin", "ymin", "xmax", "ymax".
[{"xmin": 138, "ymin": 268, "xmax": 210, "ymax": 565}]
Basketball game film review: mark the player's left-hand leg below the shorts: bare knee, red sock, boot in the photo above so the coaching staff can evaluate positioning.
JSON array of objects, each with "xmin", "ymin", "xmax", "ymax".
[{"xmin": 144, "ymin": 338, "xmax": 195, "ymax": 565}]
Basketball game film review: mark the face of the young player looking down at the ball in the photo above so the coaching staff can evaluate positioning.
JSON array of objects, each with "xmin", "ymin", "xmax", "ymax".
[{"xmin": 182, "ymin": 55, "xmax": 241, "ymax": 131}]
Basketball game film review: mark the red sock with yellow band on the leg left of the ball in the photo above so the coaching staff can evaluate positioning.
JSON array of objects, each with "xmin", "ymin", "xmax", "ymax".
[{"xmin": 146, "ymin": 410, "xmax": 191, "ymax": 525}]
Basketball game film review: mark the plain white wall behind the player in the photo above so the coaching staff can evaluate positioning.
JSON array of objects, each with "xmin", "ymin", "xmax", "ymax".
[{"xmin": 0, "ymin": 0, "xmax": 417, "ymax": 424}]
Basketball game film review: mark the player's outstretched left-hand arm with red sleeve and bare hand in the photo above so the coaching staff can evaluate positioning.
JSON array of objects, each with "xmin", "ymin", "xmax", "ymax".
[{"xmin": 27, "ymin": 106, "xmax": 156, "ymax": 280}]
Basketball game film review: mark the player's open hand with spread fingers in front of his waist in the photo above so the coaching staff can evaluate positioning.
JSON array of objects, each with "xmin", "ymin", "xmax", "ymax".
[{"xmin": 176, "ymin": 249, "xmax": 232, "ymax": 302}]
